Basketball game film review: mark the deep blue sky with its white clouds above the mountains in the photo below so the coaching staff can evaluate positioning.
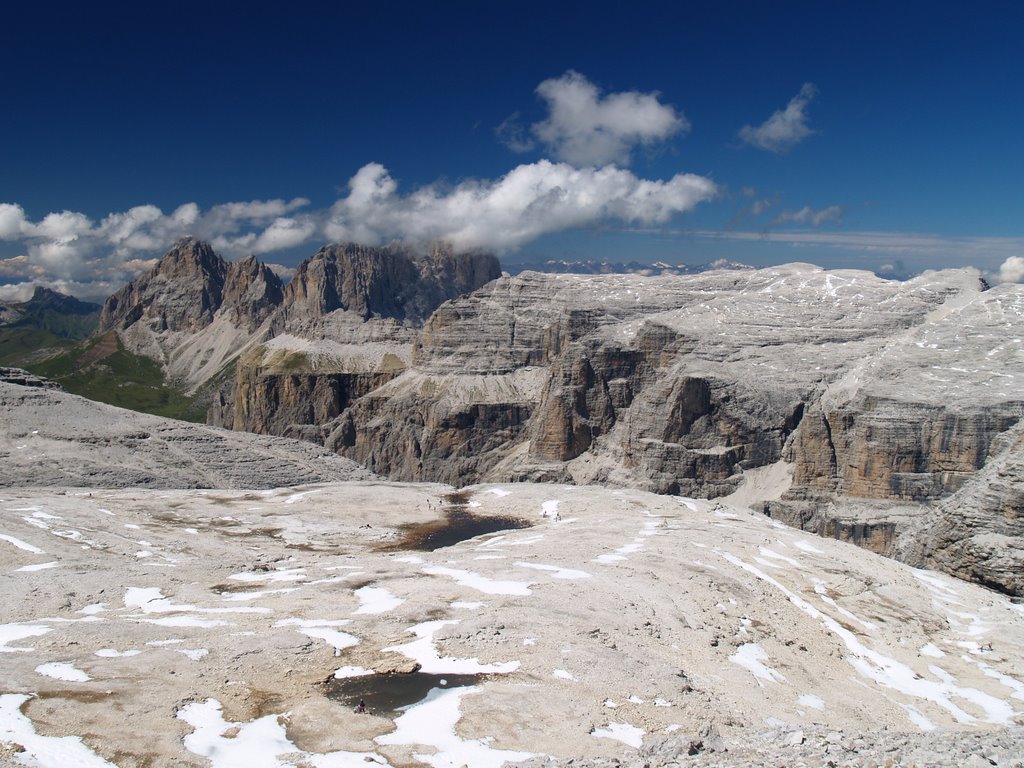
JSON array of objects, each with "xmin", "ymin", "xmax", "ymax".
[{"xmin": 0, "ymin": 2, "xmax": 1024, "ymax": 298}]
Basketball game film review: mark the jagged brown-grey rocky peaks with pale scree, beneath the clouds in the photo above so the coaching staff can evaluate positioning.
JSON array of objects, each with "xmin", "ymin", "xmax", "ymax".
[{"xmin": 99, "ymin": 238, "xmax": 499, "ymax": 392}]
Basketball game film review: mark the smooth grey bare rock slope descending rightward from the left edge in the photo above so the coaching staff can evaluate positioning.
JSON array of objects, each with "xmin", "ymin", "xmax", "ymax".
[{"xmin": 0, "ymin": 378, "xmax": 374, "ymax": 488}]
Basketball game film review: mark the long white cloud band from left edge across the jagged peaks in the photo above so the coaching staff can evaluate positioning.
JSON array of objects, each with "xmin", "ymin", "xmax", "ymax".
[{"xmin": 0, "ymin": 160, "xmax": 718, "ymax": 297}]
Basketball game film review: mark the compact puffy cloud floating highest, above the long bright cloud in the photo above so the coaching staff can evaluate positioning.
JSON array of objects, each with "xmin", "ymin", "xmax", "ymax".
[{"xmin": 528, "ymin": 70, "xmax": 689, "ymax": 167}]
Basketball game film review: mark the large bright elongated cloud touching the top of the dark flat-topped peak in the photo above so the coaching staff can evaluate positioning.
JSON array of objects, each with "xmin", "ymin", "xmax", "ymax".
[{"xmin": 325, "ymin": 160, "xmax": 717, "ymax": 251}]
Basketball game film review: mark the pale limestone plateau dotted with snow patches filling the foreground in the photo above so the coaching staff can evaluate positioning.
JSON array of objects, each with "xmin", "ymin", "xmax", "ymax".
[{"xmin": 0, "ymin": 385, "xmax": 1024, "ymax": 768}]
